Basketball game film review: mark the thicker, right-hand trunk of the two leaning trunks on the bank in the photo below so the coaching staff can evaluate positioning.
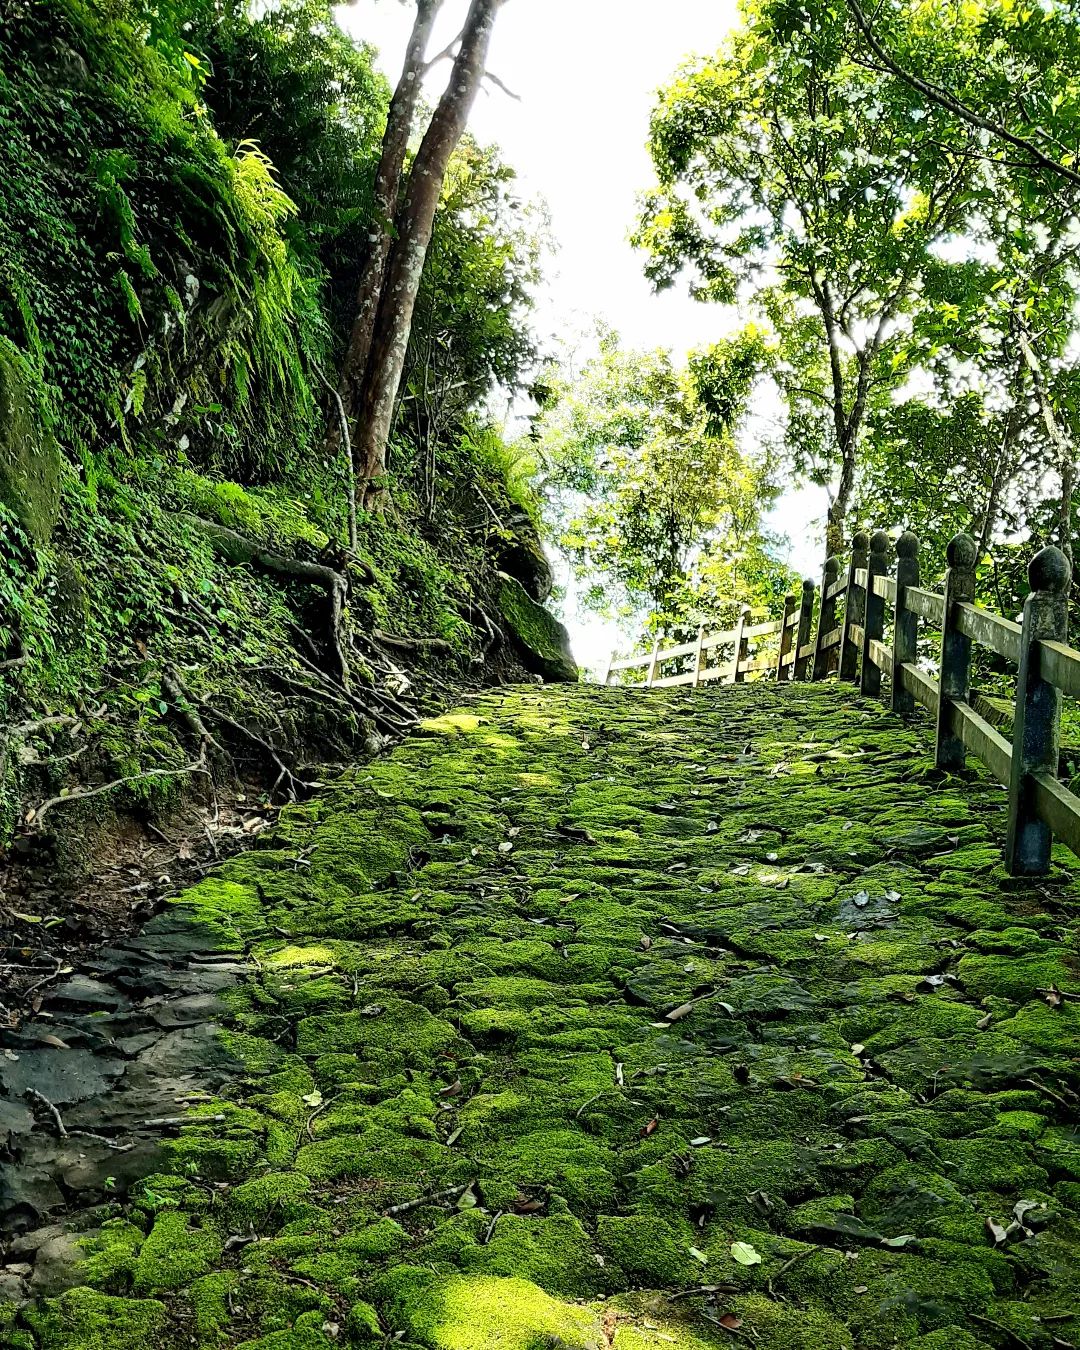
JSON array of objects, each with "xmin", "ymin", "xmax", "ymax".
[{"xmin": 356, "ymin": 0, "xmax": 502, "ymax": 505}]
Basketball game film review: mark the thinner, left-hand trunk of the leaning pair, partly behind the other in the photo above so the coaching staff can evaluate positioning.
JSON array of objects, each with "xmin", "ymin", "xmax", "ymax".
[{"xmin": 327, "ymin": 0, "xmax": 443, "ymax": 452}]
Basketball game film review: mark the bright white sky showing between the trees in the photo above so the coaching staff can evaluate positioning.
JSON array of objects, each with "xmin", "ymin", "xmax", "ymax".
[{"xmin": 336, "ymin": 0, "xmax": 824, "ymax": 664}]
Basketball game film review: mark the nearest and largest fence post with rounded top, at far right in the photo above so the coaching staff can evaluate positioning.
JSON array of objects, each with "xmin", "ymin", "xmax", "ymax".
[{"xmin": 1004, "ymin": 547, "xmax": 1072, "ymax": 876}]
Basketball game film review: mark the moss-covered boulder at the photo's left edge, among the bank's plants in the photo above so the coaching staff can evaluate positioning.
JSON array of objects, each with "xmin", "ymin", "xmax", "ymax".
[{"xmin": 0, "ymin": 343, "xmax": 61, "ymax": 544}]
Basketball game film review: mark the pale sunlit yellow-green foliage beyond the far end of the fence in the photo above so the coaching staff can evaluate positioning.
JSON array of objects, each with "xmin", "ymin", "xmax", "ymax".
[{"xmin": 537, "ymin": 331, "xmax": 790, "ymax": 632}]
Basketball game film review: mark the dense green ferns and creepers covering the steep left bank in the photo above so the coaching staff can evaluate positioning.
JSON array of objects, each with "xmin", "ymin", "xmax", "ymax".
[{"xmin": 0, "ymin": 0, "xmax": 549, "ymax": 846}]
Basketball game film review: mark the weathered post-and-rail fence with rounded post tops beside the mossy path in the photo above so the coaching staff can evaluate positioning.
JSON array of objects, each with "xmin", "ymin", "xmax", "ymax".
[{"xmin": 608, "ymin": 532, "xmax": 1080, "ymax": 876}]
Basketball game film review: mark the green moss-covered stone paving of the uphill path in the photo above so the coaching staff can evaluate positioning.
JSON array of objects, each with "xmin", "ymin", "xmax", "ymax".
[{"xmin": 10, "ymin": 684, "xmax": 1080, "ymax": 1350}]
